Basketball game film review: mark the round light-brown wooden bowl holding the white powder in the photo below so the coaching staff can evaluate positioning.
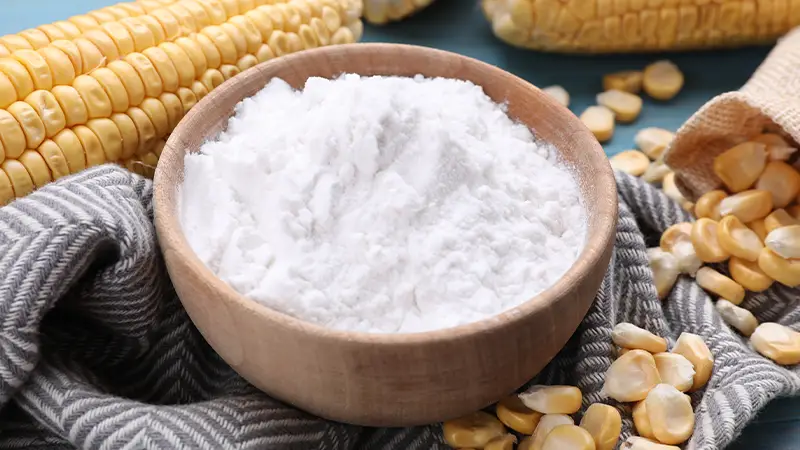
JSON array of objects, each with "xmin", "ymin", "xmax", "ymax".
[{"xmin": 155, "ymin": 44, "xmax": 617, "ymax": 426}]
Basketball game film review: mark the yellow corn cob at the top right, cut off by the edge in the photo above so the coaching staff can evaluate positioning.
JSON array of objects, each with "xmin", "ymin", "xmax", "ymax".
[{"xmin": 481, "ymin": 0, "xmax": 800, "ymax": 53}]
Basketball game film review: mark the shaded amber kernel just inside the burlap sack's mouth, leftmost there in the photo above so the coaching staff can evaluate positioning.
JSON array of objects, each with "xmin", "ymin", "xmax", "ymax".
[{"xmin": 714, "ymin": 141, "xmax": 767, "ymax": 193}]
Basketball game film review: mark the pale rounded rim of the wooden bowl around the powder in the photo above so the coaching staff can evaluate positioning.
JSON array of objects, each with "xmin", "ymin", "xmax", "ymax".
[{"xmin": 153, "ymin": 43, "xmax": 618, "ymax": 346}]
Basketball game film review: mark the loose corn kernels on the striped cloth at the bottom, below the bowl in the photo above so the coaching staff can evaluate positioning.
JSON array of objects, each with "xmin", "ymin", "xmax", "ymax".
[{"xmin": 442, "ymin": 323, "xmax": 714, "ymax": 450}]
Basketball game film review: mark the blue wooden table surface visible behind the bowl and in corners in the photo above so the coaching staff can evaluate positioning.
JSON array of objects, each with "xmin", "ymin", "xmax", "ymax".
[{"xmin": 0, "ymin": 0, "xmax": 800, "ymax": 450}]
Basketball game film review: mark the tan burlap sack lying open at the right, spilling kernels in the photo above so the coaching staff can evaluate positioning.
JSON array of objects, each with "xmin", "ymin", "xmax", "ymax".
[{"xmin": 664, "ymin": 28, "xmax": 800, "ymax": 200}]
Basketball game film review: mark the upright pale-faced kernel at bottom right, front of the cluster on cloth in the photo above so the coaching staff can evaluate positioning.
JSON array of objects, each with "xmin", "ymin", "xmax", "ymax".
[{"xmin": 645, "ymin": 384, "xmax": 694, "ymax": 445}]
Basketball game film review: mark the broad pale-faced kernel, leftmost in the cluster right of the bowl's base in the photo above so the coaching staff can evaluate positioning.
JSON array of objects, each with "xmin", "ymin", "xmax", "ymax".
[{"xmin": 603, "ymin": 350, "xmax": 661, "ymax": 402}]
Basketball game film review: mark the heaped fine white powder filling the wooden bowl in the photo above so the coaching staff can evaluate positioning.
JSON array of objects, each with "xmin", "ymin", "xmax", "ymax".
[{"xmin": 180, "ymin": 75, "xmax": 586, "ymax": 333}]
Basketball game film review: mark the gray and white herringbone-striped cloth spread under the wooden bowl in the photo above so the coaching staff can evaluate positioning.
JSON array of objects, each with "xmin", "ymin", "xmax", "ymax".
[{"xmin": 0, "ymin": 165, "xmax": 800, "ymax": 450}]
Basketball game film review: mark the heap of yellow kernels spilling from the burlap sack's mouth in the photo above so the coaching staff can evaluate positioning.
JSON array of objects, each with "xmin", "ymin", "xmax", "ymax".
[{"xmin": 611, "ymin": 128, "xmax": 800, "ymax": 365}]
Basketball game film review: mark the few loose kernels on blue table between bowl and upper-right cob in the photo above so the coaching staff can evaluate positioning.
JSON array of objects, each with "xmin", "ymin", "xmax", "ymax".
[{"xmin": 542, "ymin": 60, "xmax": 683, "ymax": 142}]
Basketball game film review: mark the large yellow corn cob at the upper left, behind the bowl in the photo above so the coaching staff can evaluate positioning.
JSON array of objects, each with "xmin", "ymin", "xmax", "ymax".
[{"xmin": 0, "ymin": 0, "xmax": 362, "ymax": 205}]
